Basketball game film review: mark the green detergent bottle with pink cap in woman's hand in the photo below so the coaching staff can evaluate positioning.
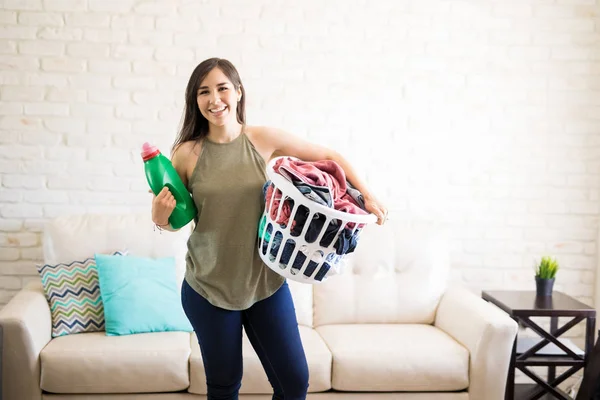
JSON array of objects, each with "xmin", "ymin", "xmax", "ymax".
[{"xmin": 142, "ymin": 143, "xmax": 198, "ymax": 229}]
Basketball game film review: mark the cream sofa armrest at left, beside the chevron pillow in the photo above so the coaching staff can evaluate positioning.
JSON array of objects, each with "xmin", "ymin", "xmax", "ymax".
[{"xmin": 0, "ymin": 282, "xmax": 52, "ymax": 400}]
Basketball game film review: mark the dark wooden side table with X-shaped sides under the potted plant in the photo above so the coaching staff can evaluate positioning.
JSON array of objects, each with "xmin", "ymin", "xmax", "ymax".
[{"xmin": 482, "ymin": 291, "xmax": 596, "ymax": 400}]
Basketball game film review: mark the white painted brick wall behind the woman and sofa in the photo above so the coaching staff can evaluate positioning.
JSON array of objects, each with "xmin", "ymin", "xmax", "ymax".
[{"xmin": 0, "ymin": 0, "xmax": 600, "ymax": 346}]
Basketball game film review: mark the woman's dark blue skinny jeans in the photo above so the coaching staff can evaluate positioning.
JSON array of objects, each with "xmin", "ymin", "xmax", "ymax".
[{"xmin": 181, "ymin": 280, "xmax": 308, "ymax": 400}]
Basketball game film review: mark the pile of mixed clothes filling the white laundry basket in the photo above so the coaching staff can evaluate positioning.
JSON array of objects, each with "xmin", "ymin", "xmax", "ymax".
[{"xmin": 259, "ymin": 157, "xmax": 368, "ymax": 281}]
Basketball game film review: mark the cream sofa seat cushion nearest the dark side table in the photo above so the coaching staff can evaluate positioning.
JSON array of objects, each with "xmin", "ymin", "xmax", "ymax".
[{"xmin": 316, "ymin": 324, "xmax": 469, "ymax": 392}]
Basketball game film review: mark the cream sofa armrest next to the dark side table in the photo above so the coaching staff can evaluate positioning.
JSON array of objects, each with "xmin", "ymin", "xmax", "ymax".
[{"xmin": 434, "ymin": 288, "xmax": 518, "ymax": 400}]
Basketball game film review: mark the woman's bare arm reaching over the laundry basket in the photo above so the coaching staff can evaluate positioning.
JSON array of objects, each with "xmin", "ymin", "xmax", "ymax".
[{"xmin": 257, "ymin": 127, "xmax": 388, "ymax": 225}]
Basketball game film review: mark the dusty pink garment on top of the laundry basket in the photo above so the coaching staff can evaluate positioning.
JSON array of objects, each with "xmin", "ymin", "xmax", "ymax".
[{"xmin": 273, "ymin": 157, "xmax": 368, "ymax": 219}]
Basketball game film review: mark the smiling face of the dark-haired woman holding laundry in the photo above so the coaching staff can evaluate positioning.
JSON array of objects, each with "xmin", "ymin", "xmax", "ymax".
[{"xmin": 196, "ymin": 67, "xmax": 242, "ymax": 126}]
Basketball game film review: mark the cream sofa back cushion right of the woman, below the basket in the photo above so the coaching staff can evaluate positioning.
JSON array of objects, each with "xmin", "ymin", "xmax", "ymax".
[{"xmin": 314, "ymin": 221, "xmax": 450, "ymax": 326}]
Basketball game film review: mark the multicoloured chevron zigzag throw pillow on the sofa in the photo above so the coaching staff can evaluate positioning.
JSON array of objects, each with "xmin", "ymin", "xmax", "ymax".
[{"xmin": 37, "ymin": 251, "xmax": 127, "ymax": 337}]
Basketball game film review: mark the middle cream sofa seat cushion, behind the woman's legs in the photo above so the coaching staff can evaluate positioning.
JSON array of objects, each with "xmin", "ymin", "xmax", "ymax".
[{"xmin": 189, "ymin": 325, "xmax": 331, "ymax": 394}]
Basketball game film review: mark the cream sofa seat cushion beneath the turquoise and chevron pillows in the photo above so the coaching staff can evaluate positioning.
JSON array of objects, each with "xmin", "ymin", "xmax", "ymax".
[{"xmin": 40, "ymin": 332, "xmax": 191, "ymax": 393}]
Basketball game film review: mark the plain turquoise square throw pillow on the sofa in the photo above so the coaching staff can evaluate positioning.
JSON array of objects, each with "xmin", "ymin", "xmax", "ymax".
[{"xmin": 95, "ymin": 254, "xmax": 192, "ymax": 336}]
